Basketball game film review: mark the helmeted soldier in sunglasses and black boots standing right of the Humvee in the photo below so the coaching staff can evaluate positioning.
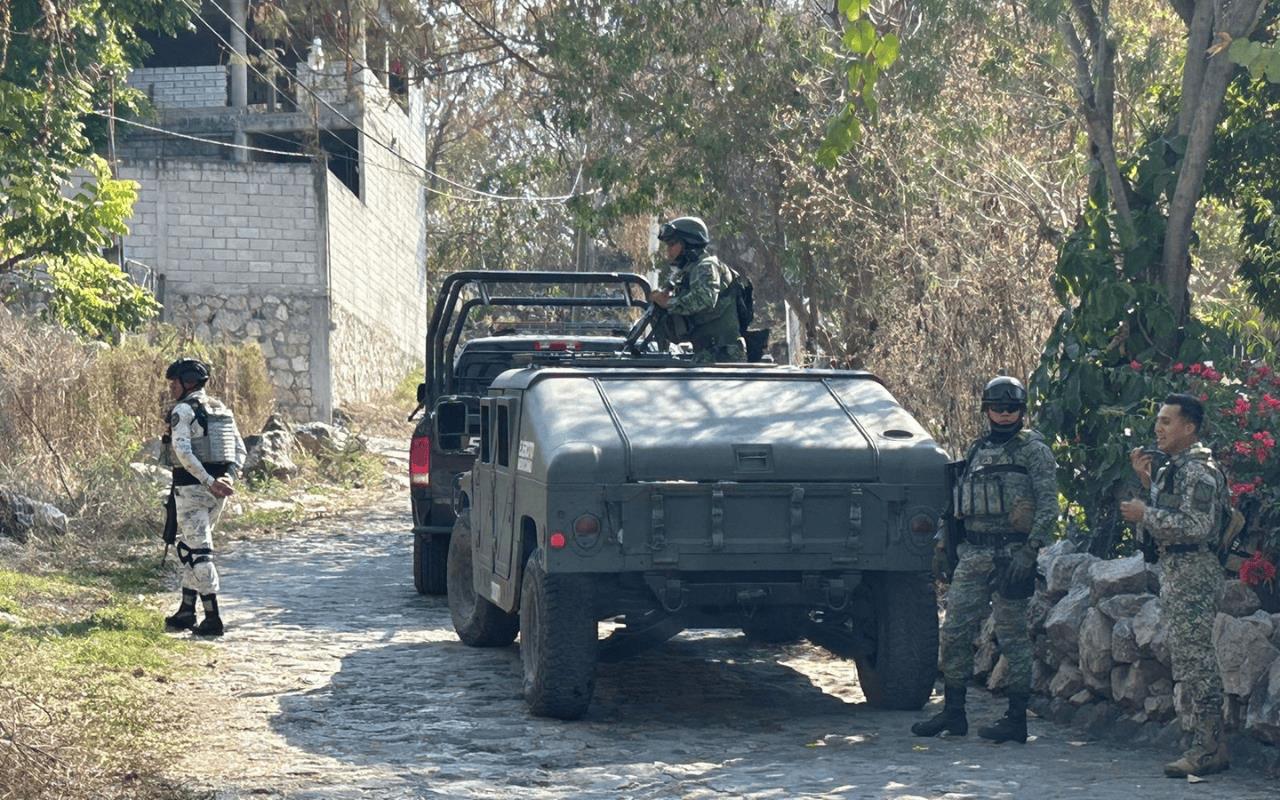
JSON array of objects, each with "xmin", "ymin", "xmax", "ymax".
[{"xmin": 911, "ymin": 376, "xmax": 1057, "ymax": 742}]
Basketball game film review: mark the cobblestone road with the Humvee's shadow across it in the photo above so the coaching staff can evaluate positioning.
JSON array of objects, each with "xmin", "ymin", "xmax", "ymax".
[{"xmin": 184, "ymin": 499, "xmax": 1275, "ymax": 800}]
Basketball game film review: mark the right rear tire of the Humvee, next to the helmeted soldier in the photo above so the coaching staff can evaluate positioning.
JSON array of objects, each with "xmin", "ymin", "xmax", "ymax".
[{"xmin": 854, "ymin": 572, "xmax": 938, "ymax": 710}]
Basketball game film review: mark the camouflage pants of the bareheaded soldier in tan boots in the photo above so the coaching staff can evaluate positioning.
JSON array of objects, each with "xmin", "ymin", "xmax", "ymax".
[{"xmin": 1160, "ymin": 553, "xmax": 1222, "ymax": 750}]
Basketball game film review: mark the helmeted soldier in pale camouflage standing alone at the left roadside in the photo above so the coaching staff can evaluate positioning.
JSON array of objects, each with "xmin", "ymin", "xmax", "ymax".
[{"xmin": 164, "ymin": 358, "xmax": 246, "ymax": 636}]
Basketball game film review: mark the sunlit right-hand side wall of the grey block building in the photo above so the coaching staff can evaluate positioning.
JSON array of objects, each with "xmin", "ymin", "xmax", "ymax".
[{"xmin": 326, "ymin": 84, "xmax": 429, "ymax": 404}]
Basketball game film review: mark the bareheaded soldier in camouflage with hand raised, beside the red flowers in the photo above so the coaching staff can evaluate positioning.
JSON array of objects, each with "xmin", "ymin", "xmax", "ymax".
[{"xmin": 1120, "ymin": 394, "xmax": 1230, "ymax": 778}]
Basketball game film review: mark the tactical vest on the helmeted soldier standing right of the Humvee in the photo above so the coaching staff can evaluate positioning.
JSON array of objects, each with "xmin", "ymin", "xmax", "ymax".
[{"xmin": 955, "ymin": 430, "xmax": 1036, "ymax": 534}]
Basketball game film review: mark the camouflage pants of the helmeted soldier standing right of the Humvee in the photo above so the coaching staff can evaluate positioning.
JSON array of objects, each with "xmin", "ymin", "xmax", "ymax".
[{"xmin": 941, "ymin": 544, "xmax": 1032, "ymax": 694}]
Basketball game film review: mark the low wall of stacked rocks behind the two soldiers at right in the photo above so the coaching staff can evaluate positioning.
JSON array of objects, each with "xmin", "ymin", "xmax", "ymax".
[{"xmin": 974, "ymin": 541, "xmax": 1280, "ymax": 745}]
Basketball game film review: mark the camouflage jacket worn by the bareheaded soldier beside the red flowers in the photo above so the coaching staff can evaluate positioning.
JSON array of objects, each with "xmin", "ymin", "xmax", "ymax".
[{"xmin": 1142, "ymin": 442, "xmax": 1228, "ymax": 547}]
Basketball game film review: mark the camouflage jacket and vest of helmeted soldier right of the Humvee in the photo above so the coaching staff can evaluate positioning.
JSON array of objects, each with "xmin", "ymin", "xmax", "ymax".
[{"xmin": 955, "ymin": 430, "xmax": 1057, "ymax": 547}]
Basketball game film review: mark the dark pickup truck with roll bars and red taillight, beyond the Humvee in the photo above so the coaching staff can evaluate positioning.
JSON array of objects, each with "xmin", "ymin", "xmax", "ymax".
[{"xmin": 410, "ymin": 270, "xmax": 649, "ymax": 594}]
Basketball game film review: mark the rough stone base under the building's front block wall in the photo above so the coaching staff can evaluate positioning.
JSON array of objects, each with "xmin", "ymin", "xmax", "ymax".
[{"xmin": 165, "ymin": 294, "xmax": 328, "ymax": 420}]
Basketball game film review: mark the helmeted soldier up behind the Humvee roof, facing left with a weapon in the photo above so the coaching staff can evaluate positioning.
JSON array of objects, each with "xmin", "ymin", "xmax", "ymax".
[{"xmin": 649, "ymin": 216, "xmax": 746, "ymax": 364}]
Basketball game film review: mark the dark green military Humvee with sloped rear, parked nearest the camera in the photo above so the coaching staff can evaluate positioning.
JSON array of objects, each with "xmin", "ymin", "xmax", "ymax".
[{"xmin": 448, "ymin": 361, "xmax": 947, "ymax": 719}]
